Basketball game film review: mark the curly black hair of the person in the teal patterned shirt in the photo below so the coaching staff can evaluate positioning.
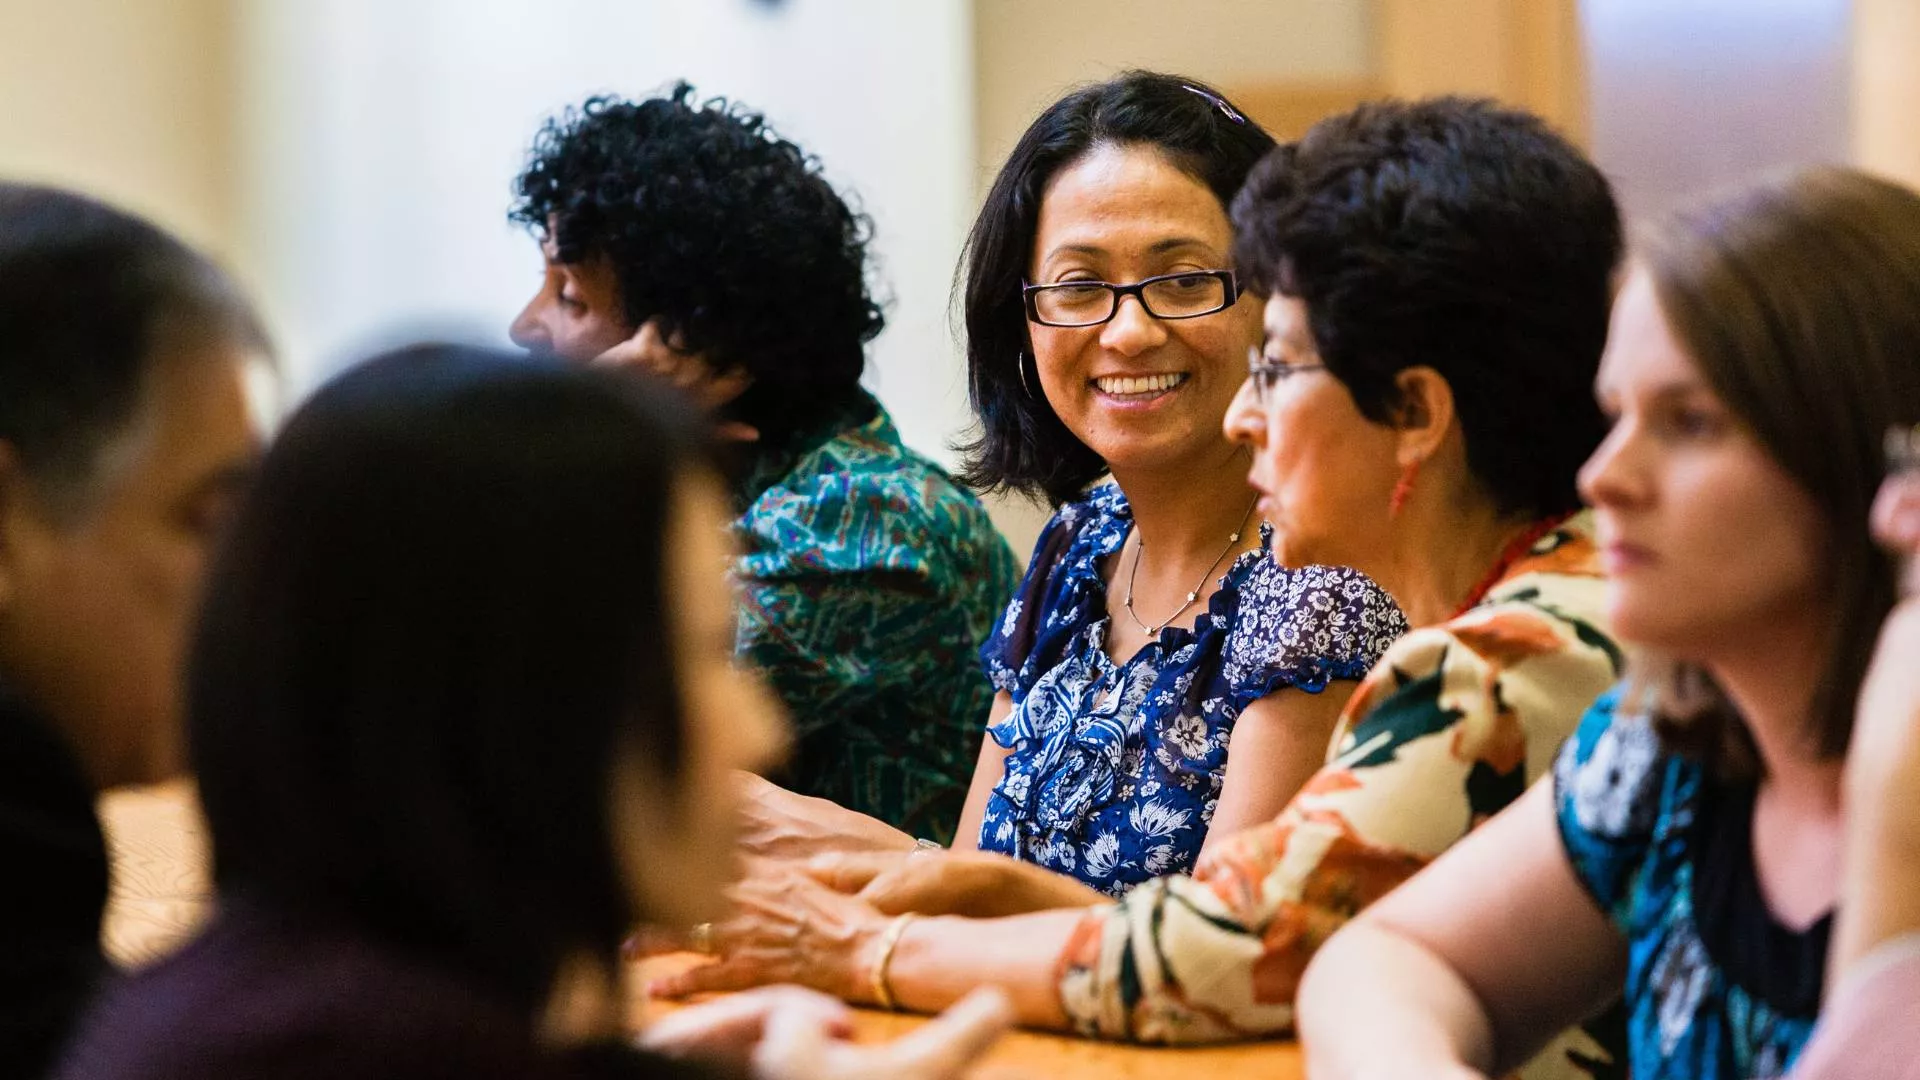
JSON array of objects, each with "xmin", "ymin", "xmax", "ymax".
[{"xmin": 511, "ymin": 83, "xmax": 885, "ymax": 438}]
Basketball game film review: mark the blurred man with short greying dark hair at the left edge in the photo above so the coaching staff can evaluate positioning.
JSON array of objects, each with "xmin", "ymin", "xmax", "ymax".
[{"xmin": 0, "ymin": 183, "xmax": 267, "ymax": 1078}]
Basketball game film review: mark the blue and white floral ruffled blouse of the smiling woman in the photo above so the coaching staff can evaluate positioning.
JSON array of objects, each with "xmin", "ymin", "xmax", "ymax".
[{"xmin": 979, "ymin": 484, "xmax": 1407, "ymax": 896}]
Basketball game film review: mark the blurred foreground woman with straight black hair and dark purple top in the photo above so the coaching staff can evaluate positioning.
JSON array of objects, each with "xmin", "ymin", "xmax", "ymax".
[{"xmin": 60, "ymin": 346, "xmax": 1006, "ymax": 1080}]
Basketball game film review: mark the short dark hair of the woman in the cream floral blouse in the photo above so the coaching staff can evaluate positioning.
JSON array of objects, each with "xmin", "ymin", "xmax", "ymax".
[{"xmin": 1233, "ymin": 98, "xmax": 1622, "ymax": 519}]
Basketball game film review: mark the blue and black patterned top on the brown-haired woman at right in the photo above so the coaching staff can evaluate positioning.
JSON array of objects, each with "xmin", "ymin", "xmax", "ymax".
[{"xmin": 1553, "ymin": 690, "xmax": 1830, "ymax": 1080}]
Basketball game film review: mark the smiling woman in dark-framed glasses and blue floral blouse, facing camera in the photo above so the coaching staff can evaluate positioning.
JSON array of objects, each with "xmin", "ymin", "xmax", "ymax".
[{"xmin": 725, "ymin": 71, "xmax": 1405, "ymax": 897}]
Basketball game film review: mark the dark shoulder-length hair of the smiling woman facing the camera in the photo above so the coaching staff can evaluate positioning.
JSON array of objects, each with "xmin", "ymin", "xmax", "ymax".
[{"xmin": 956, "ymin": 71, "xmax": 1273, "ymax": 505}]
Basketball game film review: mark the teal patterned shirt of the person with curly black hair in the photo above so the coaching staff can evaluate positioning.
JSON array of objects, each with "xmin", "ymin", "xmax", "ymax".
[{"xmin": 735, "ymin": 394, "xmax": 1018, "ymax": 842}]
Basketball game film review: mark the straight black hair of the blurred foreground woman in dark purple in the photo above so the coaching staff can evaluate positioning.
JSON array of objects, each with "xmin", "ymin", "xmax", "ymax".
[{"xmin": 188, "ymin": 346, "xmax": 710, "ymax": 1009}]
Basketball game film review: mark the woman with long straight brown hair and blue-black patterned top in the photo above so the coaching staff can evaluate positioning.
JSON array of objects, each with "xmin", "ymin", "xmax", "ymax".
[{"xmin": 1300, "ymin": 169, "xmax": 1920, "ymax": 1080}]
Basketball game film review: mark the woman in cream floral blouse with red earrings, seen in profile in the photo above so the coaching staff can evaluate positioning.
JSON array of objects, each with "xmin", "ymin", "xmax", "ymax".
[{"xmin": 645, "ymin": 100, "xmax": 1620, "ymax": 1080}]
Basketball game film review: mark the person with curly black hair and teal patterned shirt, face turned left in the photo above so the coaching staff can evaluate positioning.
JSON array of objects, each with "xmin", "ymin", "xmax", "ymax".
[{"xmin": 513, "ymin": 83, "xmax": 1016, "ymax": 840}]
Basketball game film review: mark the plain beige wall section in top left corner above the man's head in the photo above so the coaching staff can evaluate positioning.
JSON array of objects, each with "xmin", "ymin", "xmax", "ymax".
[{"xmin": 0, "ymin": 0, "xmax": 238, "ymax": 258}]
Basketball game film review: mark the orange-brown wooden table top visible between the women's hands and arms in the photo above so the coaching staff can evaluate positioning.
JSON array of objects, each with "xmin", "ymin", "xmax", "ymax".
[{"xmin": 632, "ymin": 953, "xmax": 1306, "ymax": 1080}]
